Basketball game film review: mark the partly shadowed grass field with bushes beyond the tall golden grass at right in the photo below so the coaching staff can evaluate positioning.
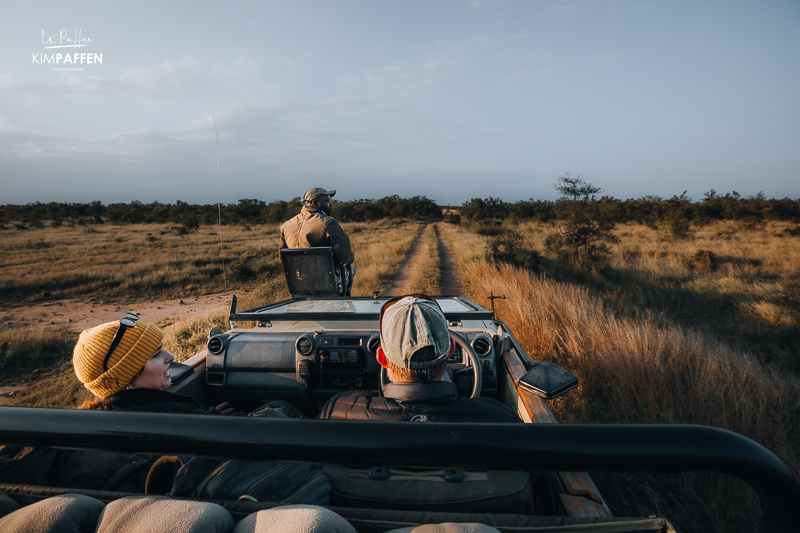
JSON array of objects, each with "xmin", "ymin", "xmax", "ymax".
[{"xmin": 514, "ymin": 222, "xmax": 800, "ymax": 373}]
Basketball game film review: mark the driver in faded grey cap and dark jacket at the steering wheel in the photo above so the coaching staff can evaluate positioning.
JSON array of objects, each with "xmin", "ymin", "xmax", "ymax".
[{"xmin": 318, "ymin": 294, "xmax": 521, "ymax": 422}]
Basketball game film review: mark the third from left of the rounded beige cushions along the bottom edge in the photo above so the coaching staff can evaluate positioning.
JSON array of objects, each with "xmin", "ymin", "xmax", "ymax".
[{"xmin": 233, "ymin": 505, "xmax": 356, "ymax": 533}]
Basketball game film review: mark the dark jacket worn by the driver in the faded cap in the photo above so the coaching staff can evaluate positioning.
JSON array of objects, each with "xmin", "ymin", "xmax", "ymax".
[{"xmin": 318, "ymin": 381, "xmax": 521, "ymax": 422}]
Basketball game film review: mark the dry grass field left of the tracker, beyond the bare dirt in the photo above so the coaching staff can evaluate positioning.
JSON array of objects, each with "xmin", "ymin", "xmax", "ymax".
[{"xmin": 0, "ymin": 224, "xmax": 280, "ymax": 303}]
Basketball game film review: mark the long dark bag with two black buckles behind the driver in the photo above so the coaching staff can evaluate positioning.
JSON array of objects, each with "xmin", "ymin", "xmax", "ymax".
[{"xmin": 322, "ymin": 465, "xmax": 533, "ymax": 514}]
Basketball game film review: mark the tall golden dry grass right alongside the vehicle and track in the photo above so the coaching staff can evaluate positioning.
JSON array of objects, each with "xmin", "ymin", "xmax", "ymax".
[{"xmin": 443, "ymin": 225, "xmax": 800, "ymax": 532}]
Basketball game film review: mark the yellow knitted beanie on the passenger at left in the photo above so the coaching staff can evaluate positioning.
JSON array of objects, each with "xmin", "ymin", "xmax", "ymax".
[{"xmin": 72, "ymin": 322, "xmax": 164, "ymax": 398}]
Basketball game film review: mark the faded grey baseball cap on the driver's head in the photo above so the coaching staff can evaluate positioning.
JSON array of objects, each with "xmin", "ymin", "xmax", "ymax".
[{"xmin": 381, "ymin": 296, "xmax": 450, "ymax": 369}]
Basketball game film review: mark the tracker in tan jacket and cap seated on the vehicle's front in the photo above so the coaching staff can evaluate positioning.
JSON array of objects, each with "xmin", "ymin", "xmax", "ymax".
[{"xmin": 280, "ymin": 187, "xmax": 356, "ymax": 294}]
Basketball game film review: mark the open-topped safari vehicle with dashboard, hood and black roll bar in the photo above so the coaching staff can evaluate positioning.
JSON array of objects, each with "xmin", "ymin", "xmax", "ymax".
[{"xmin": 0, "ymin": 249, "xmax": 800, "ymax": 532}]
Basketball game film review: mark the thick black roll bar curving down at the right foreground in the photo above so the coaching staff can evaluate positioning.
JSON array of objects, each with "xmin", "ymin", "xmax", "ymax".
[{"xmin": 0, "ymin": 407, "xmax": 800, "ymax": 533}]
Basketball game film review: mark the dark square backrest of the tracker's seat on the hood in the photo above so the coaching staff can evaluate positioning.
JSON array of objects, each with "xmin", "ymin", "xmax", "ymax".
[{"xmin": 280, "ymin": 246, "xmax": 341, "ymax": 297}]
